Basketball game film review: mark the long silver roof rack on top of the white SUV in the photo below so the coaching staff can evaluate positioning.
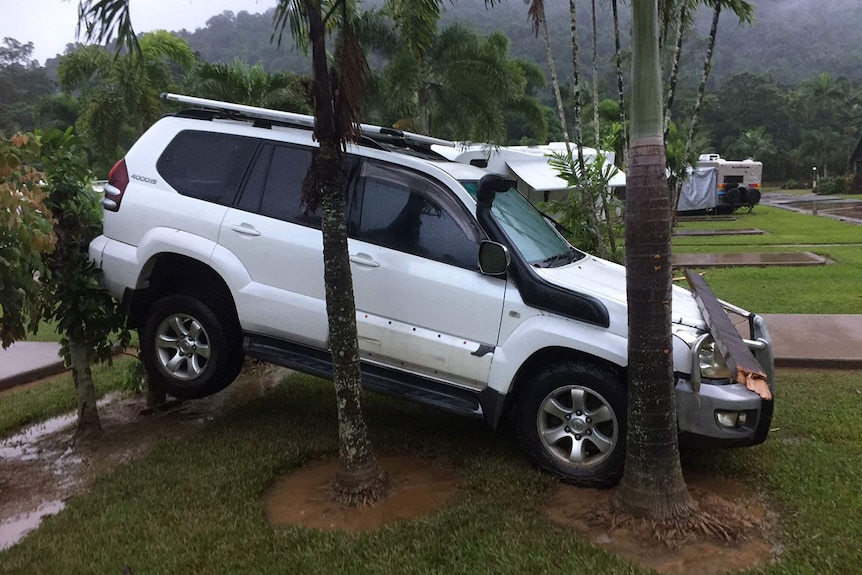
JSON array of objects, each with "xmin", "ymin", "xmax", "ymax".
[{"xmin": 162, "ymin": 92, "xmax": 456, "ymax": 148}]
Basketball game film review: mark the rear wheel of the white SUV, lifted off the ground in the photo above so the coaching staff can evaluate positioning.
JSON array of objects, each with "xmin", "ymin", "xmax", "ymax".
[{"xmin": 141, "ymin": 294, "xmax": 243, "ymax": 399}]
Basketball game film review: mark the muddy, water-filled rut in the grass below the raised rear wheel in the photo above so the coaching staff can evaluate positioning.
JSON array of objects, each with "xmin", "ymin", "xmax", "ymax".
[{"xmin": 0, "ymin": 366, "xmax": 287, "ymax": 550}]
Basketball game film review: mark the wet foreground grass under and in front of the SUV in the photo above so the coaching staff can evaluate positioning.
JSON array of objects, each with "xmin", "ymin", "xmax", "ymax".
[{"xmin": 0, "ymin": 371, "xmax": 862, "ymax": 575}]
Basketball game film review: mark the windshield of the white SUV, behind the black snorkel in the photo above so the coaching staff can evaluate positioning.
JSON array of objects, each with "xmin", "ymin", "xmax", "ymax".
[{"xmin": 461, "ymin": 182, "xmax": 584, "ymax": 267}]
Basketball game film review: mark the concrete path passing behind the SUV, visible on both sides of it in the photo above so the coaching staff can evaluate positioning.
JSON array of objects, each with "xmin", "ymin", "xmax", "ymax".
[{"xmin": 0, "ymin": 314, "xmax": 862, "ymax": 390}]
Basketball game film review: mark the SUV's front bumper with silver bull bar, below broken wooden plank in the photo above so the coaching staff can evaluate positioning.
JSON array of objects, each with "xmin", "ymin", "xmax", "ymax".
[{"xmin": 676, "ymin": 312, "xmax": 775, "ymax": 446}]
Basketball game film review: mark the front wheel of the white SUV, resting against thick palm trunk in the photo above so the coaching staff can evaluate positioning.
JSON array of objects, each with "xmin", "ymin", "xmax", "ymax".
[{"xmin": 515, "ymin": 362, "xmax": 626, "ymax": 487}]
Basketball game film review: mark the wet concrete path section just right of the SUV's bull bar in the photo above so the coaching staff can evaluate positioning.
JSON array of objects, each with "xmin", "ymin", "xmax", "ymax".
[{"xmin": 763, "ymin": 314, "xmax": 862, "ymax": 369}]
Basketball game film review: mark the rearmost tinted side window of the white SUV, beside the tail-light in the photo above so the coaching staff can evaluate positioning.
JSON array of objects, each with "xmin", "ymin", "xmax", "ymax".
[{"xmin": 156, "ymin": 130, "xmax": 257, "ymax": 206}]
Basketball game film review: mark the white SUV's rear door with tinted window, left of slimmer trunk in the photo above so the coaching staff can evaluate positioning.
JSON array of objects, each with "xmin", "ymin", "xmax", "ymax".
[{"xmin": 219, "ymin": 143, "xmax": 328, "ymax": 348}]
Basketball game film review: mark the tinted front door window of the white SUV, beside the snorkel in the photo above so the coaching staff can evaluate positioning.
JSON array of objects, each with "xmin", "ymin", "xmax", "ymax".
[{"xmin": 356, "ymin": 163, "xmax": 479, "ymax": 269}]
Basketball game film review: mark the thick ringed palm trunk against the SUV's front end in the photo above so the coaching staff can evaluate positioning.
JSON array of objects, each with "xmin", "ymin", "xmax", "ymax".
[{"xmin": 614, "ymin": 0, "xmax": 694, "ymax": 518}]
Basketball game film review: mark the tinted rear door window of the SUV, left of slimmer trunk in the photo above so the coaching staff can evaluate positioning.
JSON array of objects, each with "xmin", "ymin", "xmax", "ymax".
[{"xmin": 237, "ymin": 145, "xmax": 320, "ymax": 228}]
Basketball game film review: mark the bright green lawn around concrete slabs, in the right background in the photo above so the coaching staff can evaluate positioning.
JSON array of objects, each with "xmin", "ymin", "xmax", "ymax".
[{"xmin": 673, "ymin": 206, "xmax": 862, "ymax": 314}]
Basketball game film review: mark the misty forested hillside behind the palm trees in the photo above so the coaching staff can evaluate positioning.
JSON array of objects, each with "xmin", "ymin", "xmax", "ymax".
[{"xmin": 167, "ymin": 0, "xmax": 862, "ymax": 84}]
